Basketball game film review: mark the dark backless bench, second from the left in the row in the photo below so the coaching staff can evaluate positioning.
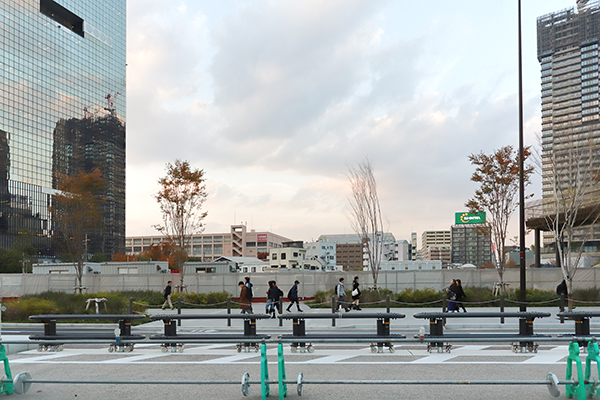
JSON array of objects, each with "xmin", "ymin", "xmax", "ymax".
[{"xmin": 149, "ymin": 314, "xmax": 271, "ymax": 353}]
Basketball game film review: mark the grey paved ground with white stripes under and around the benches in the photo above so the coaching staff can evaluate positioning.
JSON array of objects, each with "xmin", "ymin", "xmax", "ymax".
[{"xmin": 3, "ymin": 309, "xmax": 600, "ymax": 400}]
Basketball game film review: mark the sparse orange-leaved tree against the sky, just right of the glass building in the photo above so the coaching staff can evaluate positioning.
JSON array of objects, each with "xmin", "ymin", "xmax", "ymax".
[{"xmin": 154, "ymin": 159, "xmax": 208, "ymax": 288}]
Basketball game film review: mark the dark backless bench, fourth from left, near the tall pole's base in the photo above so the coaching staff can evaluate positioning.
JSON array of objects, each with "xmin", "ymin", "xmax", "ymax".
[{"xmin": 413, "ymin": 311, "xmax": 550, "ymax": 353}]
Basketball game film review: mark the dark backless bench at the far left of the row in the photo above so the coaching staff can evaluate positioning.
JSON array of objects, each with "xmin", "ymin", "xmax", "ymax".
[{"xmin": 29, "ymin": 314, "xmax": 146, "ymax": 352}]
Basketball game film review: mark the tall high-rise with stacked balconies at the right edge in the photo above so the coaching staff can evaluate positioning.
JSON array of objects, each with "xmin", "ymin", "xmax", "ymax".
[{"xmin": 537, "ymin": 0, "xmax": 600, "ymax": 247}]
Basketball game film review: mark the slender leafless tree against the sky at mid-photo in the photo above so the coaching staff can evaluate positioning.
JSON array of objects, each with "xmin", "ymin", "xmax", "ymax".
[{"xmin": 347, "ymin": 159, "xmax": 383, "ymax": 287}]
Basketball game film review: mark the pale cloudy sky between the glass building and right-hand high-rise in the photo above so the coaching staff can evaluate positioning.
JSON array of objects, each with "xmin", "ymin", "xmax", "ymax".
[{"xmin": 126, "ymin": 0, "xmax": 575, "ymax": 248}]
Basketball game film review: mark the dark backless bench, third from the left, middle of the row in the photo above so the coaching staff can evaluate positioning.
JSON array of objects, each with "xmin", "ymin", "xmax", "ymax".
[{"xmin": 279, "ymin": 312, "xmax": 406, "ymax": 353}]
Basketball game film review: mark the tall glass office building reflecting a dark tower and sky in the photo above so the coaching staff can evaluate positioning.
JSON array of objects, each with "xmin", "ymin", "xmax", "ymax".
[{"xmin": 0, "ymin": 0, "xmax": 126, "ymax": 257}]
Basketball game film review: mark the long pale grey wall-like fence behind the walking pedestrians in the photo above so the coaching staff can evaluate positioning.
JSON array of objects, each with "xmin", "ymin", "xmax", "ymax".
[{"xmin": 0, "ymin": 268, "xmax": 600, "ymax": 297}]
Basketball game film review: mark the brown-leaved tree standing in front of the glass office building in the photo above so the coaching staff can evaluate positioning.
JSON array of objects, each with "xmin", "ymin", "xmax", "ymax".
[{"xmin": 50, "ymin": 169, "xmax": 105, "ymax": 293}]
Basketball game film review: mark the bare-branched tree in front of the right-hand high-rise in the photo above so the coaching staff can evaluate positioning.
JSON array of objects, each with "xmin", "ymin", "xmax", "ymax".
[{"xmin": 541, "ymin": 134, "xmax": 600, "ymax": 310}]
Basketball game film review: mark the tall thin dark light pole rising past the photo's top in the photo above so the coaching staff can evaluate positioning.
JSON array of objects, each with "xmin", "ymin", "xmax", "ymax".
[{"xmin": 518, "ymin": 0, "xmax": 527, "ymax": 311}]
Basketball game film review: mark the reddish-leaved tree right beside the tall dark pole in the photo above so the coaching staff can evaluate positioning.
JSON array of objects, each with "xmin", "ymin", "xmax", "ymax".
[{"xmin": 465, "ymin": 146, "xmax": 533, "ymax": 287}]
